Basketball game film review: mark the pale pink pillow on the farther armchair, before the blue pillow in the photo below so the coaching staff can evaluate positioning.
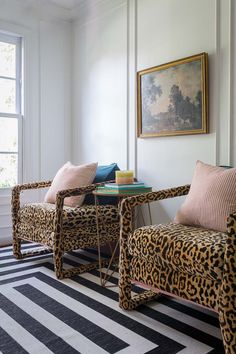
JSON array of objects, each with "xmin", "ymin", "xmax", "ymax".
[{"xmin": 44, "ymin": 162, "xmax": 97, "ymax": 207}]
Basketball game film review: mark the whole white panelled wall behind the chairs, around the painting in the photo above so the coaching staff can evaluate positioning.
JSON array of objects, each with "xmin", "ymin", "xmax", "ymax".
[{"xmin": 73, "ymin": 0, "xmax": 236, "ymax": 222}]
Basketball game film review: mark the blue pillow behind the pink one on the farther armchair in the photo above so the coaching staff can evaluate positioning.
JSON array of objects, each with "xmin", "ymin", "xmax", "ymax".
[{"xmin": 84, "ymin": 163, "xmax": 120, "ymax": 205}]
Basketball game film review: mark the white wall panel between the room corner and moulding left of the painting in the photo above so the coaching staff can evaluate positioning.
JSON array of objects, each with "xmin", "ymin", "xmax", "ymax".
[{"xmin": 73, "ymin": 0, "xmax": 127, "ymax": 168}]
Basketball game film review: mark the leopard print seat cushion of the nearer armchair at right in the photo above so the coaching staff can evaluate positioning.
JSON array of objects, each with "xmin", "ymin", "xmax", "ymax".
[{"xmin": 128, "ymin": 223, "xmax": 227, "ymax": 280}]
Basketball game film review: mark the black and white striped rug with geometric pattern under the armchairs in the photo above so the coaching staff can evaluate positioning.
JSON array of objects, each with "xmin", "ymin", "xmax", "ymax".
[{"xmin": 0, "ymin": 244, "xmax": 224, "ymax": 354}]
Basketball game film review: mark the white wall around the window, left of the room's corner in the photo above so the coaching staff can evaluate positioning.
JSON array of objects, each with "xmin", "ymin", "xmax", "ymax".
[{"xmin": 0, "ymin": 0, "xmax": 71, "ymax": 244}]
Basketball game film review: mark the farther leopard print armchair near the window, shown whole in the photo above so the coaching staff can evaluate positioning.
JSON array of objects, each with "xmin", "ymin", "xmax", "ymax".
[{"xmin": 12, "ymin": 181, "xmax": 120, "ymax": 279}]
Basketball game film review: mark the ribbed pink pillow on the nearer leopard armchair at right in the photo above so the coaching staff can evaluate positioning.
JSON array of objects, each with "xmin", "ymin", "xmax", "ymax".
[{"xmin": 174, "ymin": 161, "xmax": 236, "ymax": 232}]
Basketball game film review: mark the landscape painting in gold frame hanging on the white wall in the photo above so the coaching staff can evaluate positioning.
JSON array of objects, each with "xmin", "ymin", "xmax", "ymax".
[{"xmin": 137, "ymin": 53, "xmax": 208, "ymax": 138}]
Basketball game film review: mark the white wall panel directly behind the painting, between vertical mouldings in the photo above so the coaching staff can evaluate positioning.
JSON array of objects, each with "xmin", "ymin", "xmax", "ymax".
[{"xmin": 137, "ymin": 0, "xmax": 216, "ymax": 221}]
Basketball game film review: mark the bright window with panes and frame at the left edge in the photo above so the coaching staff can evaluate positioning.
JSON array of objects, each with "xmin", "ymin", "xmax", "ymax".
[{"xmin": 0, "ymin": 33, "xmax": 22, "ymax": 188}]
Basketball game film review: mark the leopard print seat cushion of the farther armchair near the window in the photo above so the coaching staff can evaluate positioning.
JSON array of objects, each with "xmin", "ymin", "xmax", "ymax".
[{"xmin": 19, "ymin": 203, "xmax": 119, "ymax": 230}]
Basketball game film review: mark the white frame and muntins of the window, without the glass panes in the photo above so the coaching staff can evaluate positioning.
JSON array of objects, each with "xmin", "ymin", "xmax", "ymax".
[{"xmin": 0, "ymin": 32, "xmax": 23, "ymax": 191}]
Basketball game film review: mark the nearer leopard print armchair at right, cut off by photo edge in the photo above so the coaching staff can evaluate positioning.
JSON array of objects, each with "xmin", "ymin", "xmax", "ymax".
[{"xmin": 119, "ymin": 185, "xmax": 236, "ymax": 354}]
